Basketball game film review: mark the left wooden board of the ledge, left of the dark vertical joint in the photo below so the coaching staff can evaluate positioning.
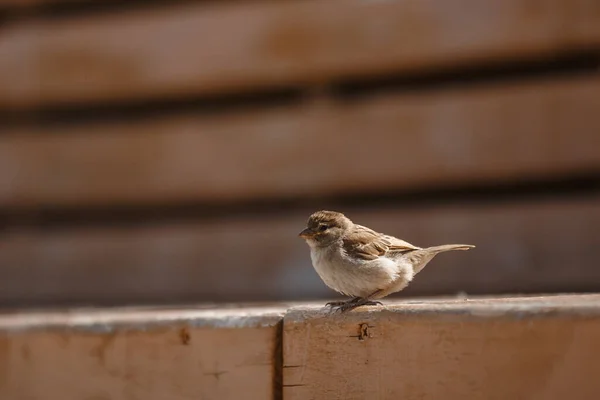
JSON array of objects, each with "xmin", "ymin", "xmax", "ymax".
[{"xmin": 0, "ymin": 307, "xmax": 284, "ymax": 400}]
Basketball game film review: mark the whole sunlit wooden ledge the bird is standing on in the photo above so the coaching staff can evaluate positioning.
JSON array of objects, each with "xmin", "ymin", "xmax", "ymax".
[{"xmin": 0, "ymin": 294, "xmax": 600, "ymax": 400}]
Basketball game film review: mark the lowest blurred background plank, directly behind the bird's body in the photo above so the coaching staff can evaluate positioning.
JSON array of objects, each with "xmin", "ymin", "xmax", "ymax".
[{"xmin": 0, "ymin": 195, "xmax": 600, "ymax": 305}]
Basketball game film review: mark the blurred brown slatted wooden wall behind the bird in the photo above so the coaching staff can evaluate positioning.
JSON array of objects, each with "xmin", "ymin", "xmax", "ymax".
[{"xmin": 0, "ymin": 0, "xmax": 600, "ymax": 306}]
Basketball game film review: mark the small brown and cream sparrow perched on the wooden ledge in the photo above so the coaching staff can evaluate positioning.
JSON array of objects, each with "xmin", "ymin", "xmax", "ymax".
[{"xmin": 298, "ymin": 211, "xmax": 475, "ymax": 312}]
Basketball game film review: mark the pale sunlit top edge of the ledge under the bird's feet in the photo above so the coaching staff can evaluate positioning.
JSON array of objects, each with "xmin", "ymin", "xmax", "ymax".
[{"xmin": 0, "ymin": 293, "xmax": 600, "ymax": 333}]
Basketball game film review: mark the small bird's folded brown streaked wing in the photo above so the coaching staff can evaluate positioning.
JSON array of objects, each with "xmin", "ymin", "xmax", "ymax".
[{"xmin": 343, "ymin": 225, "xmax": 419, "ymax": 261}]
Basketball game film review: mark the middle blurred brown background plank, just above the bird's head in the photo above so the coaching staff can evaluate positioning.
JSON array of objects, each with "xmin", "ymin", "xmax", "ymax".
[{"xmin": 0, "ymin": 75, "xmax": 600, "ymax": 207}]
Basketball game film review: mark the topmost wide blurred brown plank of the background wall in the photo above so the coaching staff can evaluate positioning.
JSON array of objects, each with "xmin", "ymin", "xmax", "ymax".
[{"xmin": 0, "ymin": 0, "xmax": 600, "ymax": 109}]
